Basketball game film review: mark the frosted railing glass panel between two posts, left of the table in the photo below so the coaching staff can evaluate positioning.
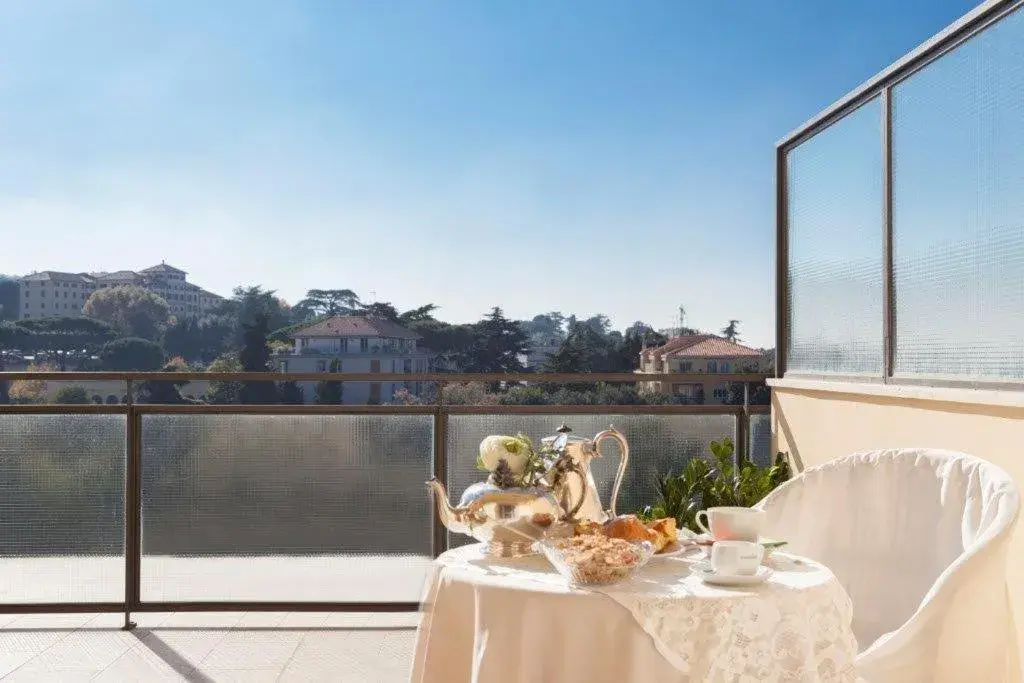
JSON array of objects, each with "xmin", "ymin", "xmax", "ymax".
[{"xmin": 142, "ymin": 415, "xmax": 433, "ymax": 601}]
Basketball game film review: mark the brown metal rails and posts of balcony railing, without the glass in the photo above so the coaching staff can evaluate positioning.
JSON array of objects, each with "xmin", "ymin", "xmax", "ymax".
[{"xmin": 0, "ymin": 372, "xmax": 769, "ymax": 629}]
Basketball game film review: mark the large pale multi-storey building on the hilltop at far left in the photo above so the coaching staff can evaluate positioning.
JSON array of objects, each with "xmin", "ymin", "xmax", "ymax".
[{"xmin": 18, "ymin": 263, "xmax": 223, "ymax": 319}]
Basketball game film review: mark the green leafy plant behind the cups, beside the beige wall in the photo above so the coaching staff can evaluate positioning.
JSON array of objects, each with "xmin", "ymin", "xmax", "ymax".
[{"xmin": 638, "ymin": 437, "xmax": 791, "ymax": 531}]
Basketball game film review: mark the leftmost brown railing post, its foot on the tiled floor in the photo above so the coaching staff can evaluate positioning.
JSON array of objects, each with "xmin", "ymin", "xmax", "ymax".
[{"xmin": 123, "ymin": 379, "xmax": 142, "ymax": 631}]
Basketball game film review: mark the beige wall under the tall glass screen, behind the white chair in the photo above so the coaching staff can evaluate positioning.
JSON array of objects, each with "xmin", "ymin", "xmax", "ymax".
[{"xmin": 772, "ymin": 386, "xmax": 1024, "ymax": 651}]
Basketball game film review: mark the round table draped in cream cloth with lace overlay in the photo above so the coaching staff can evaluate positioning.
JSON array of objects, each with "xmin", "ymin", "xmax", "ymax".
[{"xmin": 412, "ymin": 545, "xmax": 857, "ymax": 683}]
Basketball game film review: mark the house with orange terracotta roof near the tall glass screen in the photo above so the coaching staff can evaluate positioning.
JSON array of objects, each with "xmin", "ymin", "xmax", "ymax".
[{"xmin": 637, "ymin": 334, "xmax": 770, "ymax": 404}]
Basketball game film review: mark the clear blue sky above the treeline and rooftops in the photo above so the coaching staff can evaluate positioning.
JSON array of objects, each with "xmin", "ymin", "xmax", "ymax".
[{"xmin": 0, "ymin": 0, "xmax": 976, "ymax": 346}]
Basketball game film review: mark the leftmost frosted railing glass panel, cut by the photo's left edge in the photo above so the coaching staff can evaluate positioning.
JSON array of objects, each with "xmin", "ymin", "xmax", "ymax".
[{"xmin": 0, "ymin": 414, "xmax": 126, "ymax": 603}]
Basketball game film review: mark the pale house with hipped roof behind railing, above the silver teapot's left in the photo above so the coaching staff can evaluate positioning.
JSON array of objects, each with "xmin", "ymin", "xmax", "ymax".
[{"xmin": 273, "ymin": 315, "xmax": 430, "ymax": 404}]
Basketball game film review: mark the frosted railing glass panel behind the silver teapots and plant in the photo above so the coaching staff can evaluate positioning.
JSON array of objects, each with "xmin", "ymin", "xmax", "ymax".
[{"xmin": 447, "ymin": 415, "xmax": 736, "ymax": 546}]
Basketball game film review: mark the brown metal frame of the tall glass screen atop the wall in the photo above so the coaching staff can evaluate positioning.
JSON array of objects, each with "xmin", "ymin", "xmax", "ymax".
[{"xmin": 775, "ymin": 0, "xmax": 1024, "ymax": 390}]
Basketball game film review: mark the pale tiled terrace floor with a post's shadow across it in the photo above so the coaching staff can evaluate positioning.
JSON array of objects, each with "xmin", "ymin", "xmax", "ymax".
[{"xmin": 0, "ymin": 612, "xmax": 418, "ymax": 683}]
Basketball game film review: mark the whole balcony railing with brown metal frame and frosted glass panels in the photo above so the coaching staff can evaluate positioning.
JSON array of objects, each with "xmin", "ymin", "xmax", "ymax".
[{"xmin": 0, "ymin": 372, "xmax": 770, "ymax": 625}]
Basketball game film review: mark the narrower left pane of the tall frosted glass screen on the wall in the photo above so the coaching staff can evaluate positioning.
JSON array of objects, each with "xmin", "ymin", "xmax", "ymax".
[{"xmin": 786, "ymin": 99, "xmax": 883, "ymax": 376}]
